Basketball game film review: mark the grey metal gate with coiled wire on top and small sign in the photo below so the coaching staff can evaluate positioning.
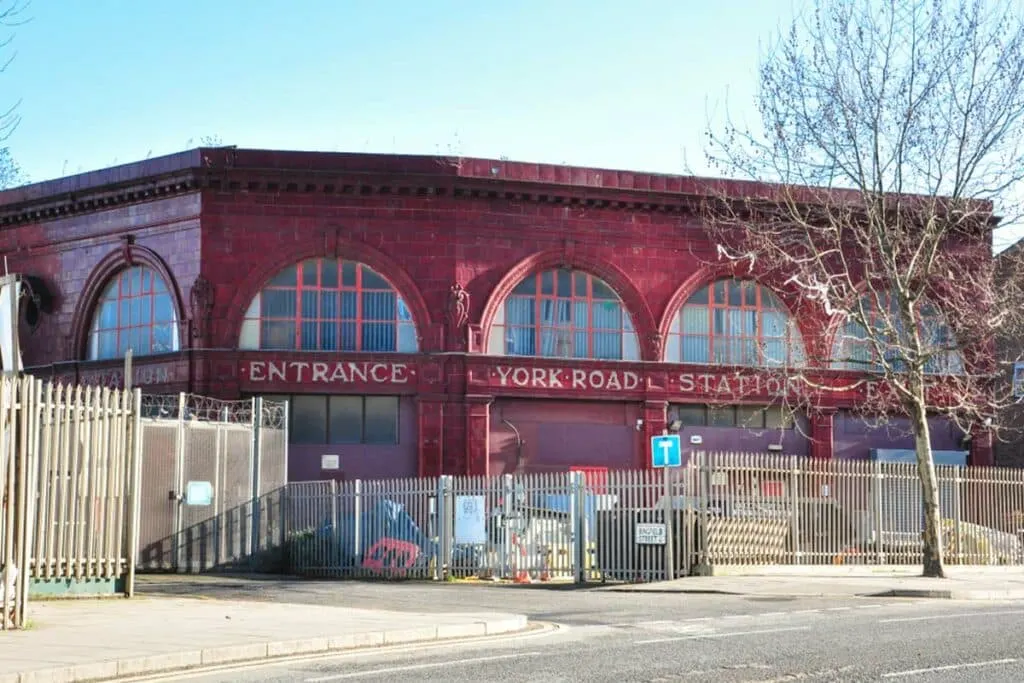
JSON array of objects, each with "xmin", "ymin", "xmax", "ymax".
[{"xmin": 136, "ymin": 394, "xmax": 288, "ymax": 571}]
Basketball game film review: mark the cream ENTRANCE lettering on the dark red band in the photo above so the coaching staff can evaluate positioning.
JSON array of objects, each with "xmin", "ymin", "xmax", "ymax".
[{"xmin": 243, "ymin": 360, "xmax": 413, "ymax": 384}]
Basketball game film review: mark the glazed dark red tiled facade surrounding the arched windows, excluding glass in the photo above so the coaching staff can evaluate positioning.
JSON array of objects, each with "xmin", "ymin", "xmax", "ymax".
[{"xmin": 0, "ymin": 148, "xmax": 991, "ymax": 478}]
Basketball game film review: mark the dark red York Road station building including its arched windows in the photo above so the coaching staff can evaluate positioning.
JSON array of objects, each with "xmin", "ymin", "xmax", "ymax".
[{"xmin": 0, "ymin": 148, "xmax": 991, "ymax": 479}]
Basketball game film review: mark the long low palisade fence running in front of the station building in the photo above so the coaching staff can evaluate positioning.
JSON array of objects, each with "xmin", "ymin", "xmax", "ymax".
[{"xmin": 283, "ymin": 453, "xmax": 1024, "ymax": 583}]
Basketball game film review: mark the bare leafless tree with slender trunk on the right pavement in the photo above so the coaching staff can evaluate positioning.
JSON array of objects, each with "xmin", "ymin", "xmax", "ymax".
[{"xmin": 703, "ymin": 0, "xmax": 1024, "ymax": 577}]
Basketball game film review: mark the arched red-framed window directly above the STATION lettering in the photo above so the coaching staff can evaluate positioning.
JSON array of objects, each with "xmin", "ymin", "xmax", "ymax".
[{"xmin": 665, "ymin": 279, "xmax": 804, "ymax": 368}]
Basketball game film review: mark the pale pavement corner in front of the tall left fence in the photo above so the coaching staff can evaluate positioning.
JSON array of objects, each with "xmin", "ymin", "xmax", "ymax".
[{"xmin": 0, "ymin": 598, "xmax": 526, "ymax": 683}]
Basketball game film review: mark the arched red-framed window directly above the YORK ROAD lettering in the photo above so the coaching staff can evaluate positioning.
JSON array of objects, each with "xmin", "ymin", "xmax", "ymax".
[{"xmin": 487, "ymin": 268, "xmax": 640, "ymax": 360}]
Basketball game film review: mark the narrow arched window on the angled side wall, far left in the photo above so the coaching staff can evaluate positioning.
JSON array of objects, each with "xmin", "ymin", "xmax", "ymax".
[{"xmin": 88, "ymin": 265, "xmax": 178, "ymax": 360}]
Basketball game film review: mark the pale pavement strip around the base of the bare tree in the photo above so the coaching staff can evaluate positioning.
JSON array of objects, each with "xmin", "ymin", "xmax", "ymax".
[{"xmin": 599, "ymin": 567, "xmax": 1024, "ymax": 600}]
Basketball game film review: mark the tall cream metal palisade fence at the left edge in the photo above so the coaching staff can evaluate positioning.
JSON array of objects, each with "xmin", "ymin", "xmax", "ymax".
[{"xmin": 0, "ymin": 377, "xmax": 140, "ymax": 629}]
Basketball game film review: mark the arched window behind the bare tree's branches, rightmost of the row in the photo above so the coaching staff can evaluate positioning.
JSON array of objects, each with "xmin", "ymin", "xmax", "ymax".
[{"xmin": 831, "ymin": 294, "xmax": 964, "ymax": 375}]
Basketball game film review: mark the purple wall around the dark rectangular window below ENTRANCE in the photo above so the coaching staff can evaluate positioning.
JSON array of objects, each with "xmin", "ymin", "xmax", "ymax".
[{"xmin": 288, "ymin": 397, "xmax": 418, "ymax": 481}]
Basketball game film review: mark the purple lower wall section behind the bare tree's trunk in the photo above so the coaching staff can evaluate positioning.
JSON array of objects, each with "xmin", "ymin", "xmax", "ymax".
[{"xmin": 833, "ymin": 411, "xmax": 964, "ymax": 460}]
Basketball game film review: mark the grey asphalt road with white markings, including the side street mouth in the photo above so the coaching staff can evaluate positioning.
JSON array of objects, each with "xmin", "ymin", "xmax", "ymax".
[{"xmin": 142, "ymin": 580, "xmax": 1024, "ymax": 683}]
